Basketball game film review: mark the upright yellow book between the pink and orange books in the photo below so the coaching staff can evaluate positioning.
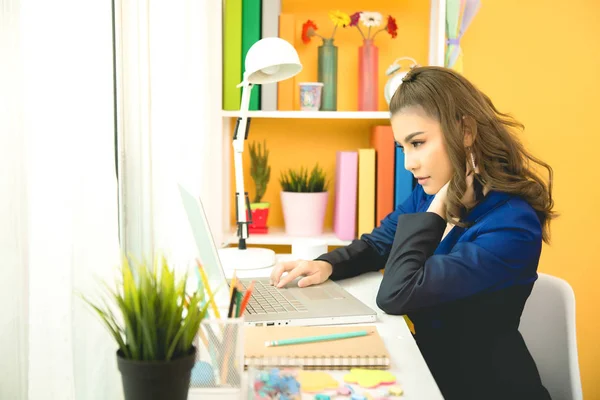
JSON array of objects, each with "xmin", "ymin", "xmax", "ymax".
[{"xmin": 356, "ymin": 149, "xmax": 375, "ymax": 237}]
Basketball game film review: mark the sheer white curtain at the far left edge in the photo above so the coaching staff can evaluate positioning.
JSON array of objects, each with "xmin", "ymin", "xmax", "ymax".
[{"xmin": 0, "ymin": 0, "xmax": 122, "ymax": 400}]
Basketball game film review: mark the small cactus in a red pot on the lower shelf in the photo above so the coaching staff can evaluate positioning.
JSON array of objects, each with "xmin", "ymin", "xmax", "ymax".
[{"xmin": 248, "ymin": 141, "xmax": 271, "ymax": 233}]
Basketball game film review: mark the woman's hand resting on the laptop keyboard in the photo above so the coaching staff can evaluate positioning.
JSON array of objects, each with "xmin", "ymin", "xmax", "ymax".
[{"xmin": 271, "ymin": 260, "xmax": 333, "ymax": 288}]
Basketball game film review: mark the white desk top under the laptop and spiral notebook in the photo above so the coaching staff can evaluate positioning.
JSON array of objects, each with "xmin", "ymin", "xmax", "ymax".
[{"xmin": 227, "ymin": 257, "xmax": 443, "ymax": 400}]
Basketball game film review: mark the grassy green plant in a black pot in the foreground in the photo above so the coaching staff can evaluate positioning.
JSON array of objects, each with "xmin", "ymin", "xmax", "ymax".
[{"xmin": 82, "ymin": 257, "xmax": 209, "ymax": 400}]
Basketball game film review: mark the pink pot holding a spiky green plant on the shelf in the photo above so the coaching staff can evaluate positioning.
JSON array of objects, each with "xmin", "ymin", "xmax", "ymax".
[{"xmin": 281, "ymin": 192, "xmax": 329, "ymax": 236}]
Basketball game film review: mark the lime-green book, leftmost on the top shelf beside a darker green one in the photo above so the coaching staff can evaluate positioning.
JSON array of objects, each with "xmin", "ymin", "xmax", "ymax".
[{"xmin": 223, "ymin": 0, "xmax": 242, "ymax": 110}]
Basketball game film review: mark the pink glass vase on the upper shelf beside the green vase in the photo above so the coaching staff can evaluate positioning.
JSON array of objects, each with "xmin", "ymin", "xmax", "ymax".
[{"xmin": 358, "ymin": 39, "xmax": 379, "ymax": 111}]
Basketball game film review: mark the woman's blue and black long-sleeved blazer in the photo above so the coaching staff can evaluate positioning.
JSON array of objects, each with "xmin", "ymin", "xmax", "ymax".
[{"xmin": 318, "ymin": 186, "xmax": 550, "ymax": 400}]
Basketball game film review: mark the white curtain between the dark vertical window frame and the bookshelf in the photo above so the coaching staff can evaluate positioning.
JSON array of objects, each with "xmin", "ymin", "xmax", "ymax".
[{"xmin": 117, "ymin": 0, "xmax": 221, "ymax": 268}]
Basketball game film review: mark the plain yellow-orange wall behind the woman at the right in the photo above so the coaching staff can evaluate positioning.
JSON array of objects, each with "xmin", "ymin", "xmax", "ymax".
[{"xmin": 464, "ymin": 0, "xmax": 600, "ymax": 399}]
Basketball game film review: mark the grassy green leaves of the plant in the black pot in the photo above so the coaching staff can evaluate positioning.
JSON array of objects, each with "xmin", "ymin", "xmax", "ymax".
[{"xmin": 82, "ymin": 253, "xmax": 210, "ymax": 361}]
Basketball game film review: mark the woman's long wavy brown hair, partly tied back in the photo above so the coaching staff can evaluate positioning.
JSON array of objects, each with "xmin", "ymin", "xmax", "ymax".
[{"xmin": 390, "ymin": 67, "xmax": 556, "ymax": 243}]
